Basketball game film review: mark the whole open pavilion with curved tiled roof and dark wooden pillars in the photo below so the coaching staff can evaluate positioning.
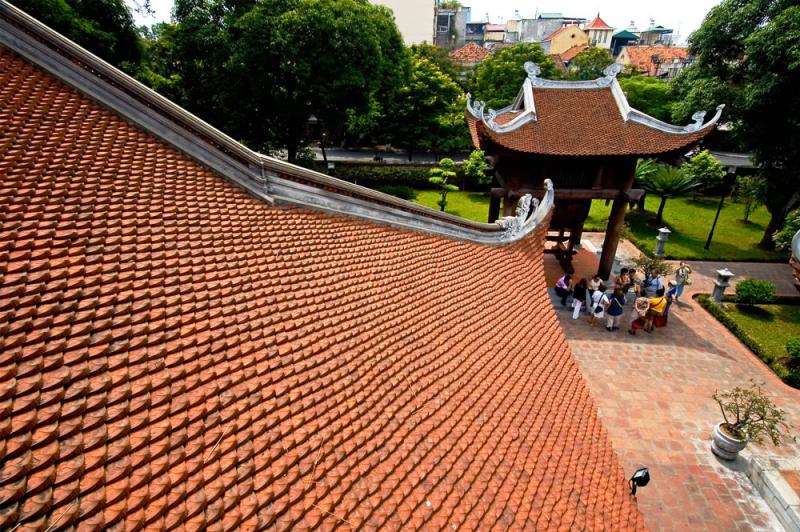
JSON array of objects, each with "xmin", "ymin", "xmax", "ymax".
[{"xmin": 467, "ymin": 62, "xmax": 723, "ymax": 279}]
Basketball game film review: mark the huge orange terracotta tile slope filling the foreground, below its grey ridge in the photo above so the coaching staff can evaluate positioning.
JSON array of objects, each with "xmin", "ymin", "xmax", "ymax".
[{"xmin": 0, "ymin": 49, "xmax": 643, "ymax": 530}]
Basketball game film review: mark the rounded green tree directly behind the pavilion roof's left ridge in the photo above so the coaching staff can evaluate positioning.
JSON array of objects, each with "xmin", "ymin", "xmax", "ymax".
[{"xmin": 472, "ymin": 43, "xmax": 556, "ymax": 109}]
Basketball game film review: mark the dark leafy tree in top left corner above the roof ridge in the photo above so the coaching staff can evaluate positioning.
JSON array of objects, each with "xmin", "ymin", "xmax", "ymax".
[{"xmin": 11, "ymin": 0, "xmax": 143, "ymax": 73}]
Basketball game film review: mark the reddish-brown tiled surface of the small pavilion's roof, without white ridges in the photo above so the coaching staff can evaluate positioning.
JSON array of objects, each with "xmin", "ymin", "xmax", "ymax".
[{"xmin": 467, "ymin": 87, "xmax": 709, "ymax": 156}]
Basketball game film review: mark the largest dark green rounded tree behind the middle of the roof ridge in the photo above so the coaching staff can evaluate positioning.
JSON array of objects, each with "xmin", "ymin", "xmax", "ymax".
[{"xmin": 153, "ymin": 0, "xmax": 408, "ymax": 161}]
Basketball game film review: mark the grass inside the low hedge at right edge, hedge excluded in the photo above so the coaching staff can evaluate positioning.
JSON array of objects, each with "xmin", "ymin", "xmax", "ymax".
[{"xmin": 725, "ymin": 304, "xmax": 800, "ymax": 384}]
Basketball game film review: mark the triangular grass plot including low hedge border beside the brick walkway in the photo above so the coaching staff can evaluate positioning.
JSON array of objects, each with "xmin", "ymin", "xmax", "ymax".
[{"xmin": 698, "ymin": 296, "xmax": 800, "ymax": 387}]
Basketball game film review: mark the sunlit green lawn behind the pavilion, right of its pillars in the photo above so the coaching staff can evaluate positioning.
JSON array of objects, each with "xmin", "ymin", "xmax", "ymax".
[{"xmin": 585, "ymin": 196, "xmax": 787, "ymax": 262}]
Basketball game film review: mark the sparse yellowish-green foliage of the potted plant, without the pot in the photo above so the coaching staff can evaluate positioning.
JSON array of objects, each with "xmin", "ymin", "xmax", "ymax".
[{"xmin": 713, "ymin": 381, "xmax": 789, "ymax": 445}]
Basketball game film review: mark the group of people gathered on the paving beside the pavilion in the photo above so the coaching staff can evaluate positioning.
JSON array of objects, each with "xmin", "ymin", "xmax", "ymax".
[{"xmin": 555, "ymin": 262, "xmax": 692, "ymax": 335}]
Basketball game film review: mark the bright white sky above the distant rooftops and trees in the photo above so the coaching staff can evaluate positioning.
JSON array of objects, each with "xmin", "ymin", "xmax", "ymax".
[{"xmin": 127, "ymin": 0, "xmax": 720, "ymax": 42}]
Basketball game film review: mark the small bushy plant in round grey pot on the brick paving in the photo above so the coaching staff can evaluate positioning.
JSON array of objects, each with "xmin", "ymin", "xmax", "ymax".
[{"xmin": 711, "ymin": 381, "xmax": 789, "ymax": 460}]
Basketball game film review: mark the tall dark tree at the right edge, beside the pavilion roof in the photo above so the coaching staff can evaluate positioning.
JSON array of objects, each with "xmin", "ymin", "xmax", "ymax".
[{"xmin": 674, "ymin": 0, "xmax": 800, "ymax": 247}]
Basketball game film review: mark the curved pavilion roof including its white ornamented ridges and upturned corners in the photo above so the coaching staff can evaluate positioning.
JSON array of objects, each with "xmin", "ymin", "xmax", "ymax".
[{"xmin": 467, "ymin": 63, "xmax": 722, "ymax": 156}]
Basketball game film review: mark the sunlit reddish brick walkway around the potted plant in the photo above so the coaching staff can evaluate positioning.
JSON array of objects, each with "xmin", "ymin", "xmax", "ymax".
[{"xmin": 546, "ymin": 251, "xmax": 800, "ymax": 531}]
